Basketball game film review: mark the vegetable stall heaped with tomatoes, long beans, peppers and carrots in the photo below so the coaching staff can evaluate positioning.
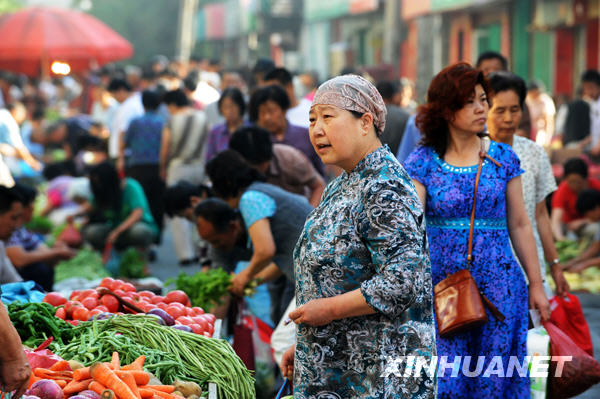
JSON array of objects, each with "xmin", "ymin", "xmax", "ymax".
[{"xmin": 7, "ymin": 277, "xmax": 256, "ymax": 399}]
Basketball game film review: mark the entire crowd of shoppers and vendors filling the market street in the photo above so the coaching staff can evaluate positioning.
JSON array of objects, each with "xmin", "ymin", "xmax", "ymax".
[{"xmin": 0, "ymin": 52, "xmax": 600, "ymax": 398}]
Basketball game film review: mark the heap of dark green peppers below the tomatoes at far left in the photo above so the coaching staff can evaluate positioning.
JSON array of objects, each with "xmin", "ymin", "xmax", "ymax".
[{"xmin": 8, "ymin": 302, "xmax": 73, "ymax": 348}]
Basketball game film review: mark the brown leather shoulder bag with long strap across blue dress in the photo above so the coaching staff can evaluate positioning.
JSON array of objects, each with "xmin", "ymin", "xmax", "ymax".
[{"xmin": 433, "ymin": 149, "xmax": 504, "ymax": 338}]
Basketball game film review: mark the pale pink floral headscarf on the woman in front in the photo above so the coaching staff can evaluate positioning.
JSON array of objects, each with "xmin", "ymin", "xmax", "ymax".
[{"xmin": 311, "ymin": 75, "xmax": 387, "ymax": 134}]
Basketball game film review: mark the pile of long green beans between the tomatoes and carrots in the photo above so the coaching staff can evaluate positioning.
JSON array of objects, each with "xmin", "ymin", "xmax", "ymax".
[{"xmin": 63, "ymin": 315, "xmax": 256, "ymax": 399}]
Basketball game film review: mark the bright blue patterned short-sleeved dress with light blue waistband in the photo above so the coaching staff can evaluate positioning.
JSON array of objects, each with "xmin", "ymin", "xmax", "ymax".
[{"xmin": 404, "ymin": 142, "xmax": 535, "ymax": 399}]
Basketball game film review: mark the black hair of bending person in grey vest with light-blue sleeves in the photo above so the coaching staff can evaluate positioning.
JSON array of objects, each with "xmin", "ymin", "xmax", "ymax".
[{"xmin": 206, "ymin": 150, "xmax": 265, "ymax": 199}]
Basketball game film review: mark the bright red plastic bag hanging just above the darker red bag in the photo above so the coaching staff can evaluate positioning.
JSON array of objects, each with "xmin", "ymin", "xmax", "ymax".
[{"xmin": 550, "ymin": 294, "xmax": 594, "ymax": 357}]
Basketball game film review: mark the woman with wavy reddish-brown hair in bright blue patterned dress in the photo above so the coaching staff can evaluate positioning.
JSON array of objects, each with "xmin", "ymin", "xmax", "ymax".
[{"xmin": 404, "ymin": 63, "xmax": 549, "ymax": 399}]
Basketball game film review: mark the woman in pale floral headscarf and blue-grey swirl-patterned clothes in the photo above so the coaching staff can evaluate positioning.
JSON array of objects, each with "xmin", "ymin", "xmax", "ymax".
[{"xmin": 282, "ymin": 75, "xmax": 436, "ymax": 399}]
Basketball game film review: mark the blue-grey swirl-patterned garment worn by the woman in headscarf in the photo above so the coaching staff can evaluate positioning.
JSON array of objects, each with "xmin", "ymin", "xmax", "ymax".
[{"xmin": 294, "ymin": 146, "xmax": 436, "ymax": 399}]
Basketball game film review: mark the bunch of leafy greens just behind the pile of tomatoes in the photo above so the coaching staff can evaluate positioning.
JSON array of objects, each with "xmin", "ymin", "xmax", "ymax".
[{"xmin": 166, "ymin": 268, "xmax": 232, "ymax": 309}]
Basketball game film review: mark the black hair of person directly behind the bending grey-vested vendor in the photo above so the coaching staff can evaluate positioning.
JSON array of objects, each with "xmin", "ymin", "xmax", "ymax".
[{"xmin": 229, "ymin": 126, "xmax": 273, "ymax": 165}]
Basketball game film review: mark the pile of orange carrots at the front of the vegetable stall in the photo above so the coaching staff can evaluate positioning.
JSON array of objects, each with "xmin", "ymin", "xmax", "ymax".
[{"xmin": 29, "ymin": 352, "xmax": 181, "ymax": 399}]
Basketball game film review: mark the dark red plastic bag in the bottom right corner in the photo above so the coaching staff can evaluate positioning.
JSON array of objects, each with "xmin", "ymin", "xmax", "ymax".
[{"xmin": 544, "ymin": 322, "xmax": 600, "ymax": 399}]
